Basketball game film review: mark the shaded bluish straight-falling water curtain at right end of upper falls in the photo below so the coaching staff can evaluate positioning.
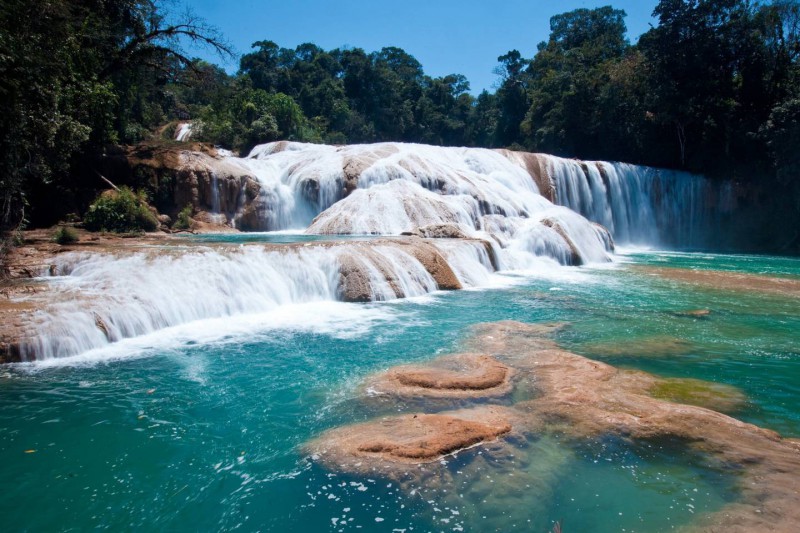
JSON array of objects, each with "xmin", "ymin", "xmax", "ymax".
[{"xmin": 547, "ymin": 156, "xmax": 731, "ymax": 248}]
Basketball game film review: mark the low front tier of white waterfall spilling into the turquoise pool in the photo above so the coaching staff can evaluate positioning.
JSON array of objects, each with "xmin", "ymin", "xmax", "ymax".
[{"xmin": 20, "ymin": 241, "xmax": 491, "ymax": 360}]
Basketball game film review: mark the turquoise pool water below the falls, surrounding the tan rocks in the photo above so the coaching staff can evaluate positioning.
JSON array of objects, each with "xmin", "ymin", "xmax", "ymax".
[{"xmin": 0, "ymin": 252, "xmax": 800, "ymax": 532}]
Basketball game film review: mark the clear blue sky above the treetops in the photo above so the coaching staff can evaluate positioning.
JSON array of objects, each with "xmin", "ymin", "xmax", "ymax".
[{"xmin": 187, "ymin": 0, "xmax": 657, "ymax": 93}]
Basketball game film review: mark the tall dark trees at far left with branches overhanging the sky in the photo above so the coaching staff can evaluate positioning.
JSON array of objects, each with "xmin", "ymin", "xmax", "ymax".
[{"xmin": 0, "ymin": 0, "xmax": 228, "ymax": 234}]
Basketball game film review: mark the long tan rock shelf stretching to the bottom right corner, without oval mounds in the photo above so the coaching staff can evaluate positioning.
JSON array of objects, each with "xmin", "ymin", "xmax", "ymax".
[{"xmin": 470, "ymin": 322, "xmax": 800, "ymax": 532}]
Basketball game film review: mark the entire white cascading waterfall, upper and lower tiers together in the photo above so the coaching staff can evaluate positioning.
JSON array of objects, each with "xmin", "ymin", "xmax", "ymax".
[{"xmin": 14, "ymin": 142, "xmax": 723, "ymax": 359}]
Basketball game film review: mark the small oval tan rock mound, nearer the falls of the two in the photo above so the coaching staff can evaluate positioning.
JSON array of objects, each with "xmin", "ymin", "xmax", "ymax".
[{"xmin": 366, "ymin": 353, "xmax": 513, "ymax": 398}]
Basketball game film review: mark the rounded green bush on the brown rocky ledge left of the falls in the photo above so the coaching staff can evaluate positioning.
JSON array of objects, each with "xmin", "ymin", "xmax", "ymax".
[{"xmin": 83, "ymin": 187, "xmax": 158, "ymax": 233}]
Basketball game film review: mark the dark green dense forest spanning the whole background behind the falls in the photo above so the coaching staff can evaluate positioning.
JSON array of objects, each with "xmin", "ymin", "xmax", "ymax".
[{"xmin": 0, "ymin": 0, "xmax": 800, "ymax": 245}]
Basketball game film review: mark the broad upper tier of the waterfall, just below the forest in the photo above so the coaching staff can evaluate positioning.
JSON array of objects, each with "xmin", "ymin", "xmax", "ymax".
[{"xmin": 169, "ymin": 142, "xmax": 734, "ymax": 248}]
